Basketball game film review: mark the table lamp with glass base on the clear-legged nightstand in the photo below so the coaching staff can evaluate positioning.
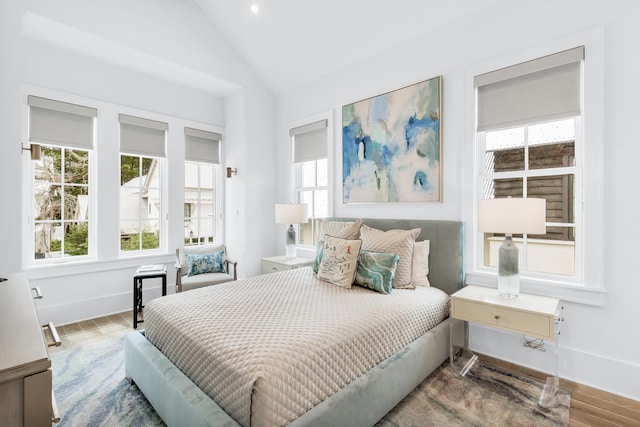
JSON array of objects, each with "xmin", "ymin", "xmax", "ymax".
[{"xmin": 478, "ymin": 197, "xmax": 547, "ymax": 298}]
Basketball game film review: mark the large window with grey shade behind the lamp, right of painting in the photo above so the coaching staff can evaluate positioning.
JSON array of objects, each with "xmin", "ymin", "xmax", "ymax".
[{"xmin": 467, "ymin": 41, "xmax": 603, "ymax": 305}]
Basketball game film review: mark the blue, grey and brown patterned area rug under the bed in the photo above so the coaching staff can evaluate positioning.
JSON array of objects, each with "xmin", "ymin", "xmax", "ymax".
[{"xmin": 51, "ymin": 338, "xmax": 570, "ymax": 427}]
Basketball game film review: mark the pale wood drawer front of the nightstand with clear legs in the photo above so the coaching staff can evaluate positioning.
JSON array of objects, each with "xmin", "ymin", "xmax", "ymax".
[{"xmin": 451, "ymin": 298, "xmax": 554, "ymax": 340}]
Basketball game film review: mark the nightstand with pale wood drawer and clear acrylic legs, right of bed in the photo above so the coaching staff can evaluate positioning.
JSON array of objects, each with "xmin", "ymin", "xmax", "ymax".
[{"xmin": 450, "ymin": 286, "xmax": 564, "ymax": 407}]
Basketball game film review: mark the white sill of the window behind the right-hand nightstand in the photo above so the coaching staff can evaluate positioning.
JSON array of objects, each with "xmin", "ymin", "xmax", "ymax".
[{"xmin": 465, "ymin": 272, "xmax": 607, "ymax": 307}]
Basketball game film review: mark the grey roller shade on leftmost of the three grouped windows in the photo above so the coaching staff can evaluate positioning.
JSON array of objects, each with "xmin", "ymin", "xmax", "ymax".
[{"xmin": 28, "ymin": 95, "xmax": 98, "ymax": 150}]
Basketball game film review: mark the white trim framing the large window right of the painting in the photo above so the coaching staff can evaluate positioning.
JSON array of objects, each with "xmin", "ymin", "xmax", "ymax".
[{"xmin": 463, "ymin": 27, "xmax": 606, "ymax": 306}]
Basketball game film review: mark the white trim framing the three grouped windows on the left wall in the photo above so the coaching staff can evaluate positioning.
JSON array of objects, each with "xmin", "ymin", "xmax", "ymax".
[{"xmin": 16, "ymin": 84, "xmax": 225, "ymax": 279}]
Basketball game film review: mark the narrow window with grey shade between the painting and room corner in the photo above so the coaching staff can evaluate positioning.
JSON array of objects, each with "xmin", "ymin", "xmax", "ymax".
[{"xmin": 289, "ymin": 120, "xmax": 329, "ymax": 246}]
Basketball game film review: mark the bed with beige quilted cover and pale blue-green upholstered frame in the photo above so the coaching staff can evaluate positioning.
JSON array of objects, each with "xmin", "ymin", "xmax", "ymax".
[{"xmin": 125, "ymin": 219, "xmax": 463, "ymax": 426}]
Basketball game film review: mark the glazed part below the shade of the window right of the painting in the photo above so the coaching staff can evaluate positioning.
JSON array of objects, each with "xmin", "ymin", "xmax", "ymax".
[{"xmin": 480, "ymin": 118, "xmax": 579, "ymax": 277}]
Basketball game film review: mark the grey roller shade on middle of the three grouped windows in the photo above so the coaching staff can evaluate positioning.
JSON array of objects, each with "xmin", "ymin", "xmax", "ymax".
[{"xmin": 119, "ymin": 114, "xmax": 169, "ymax": 157}]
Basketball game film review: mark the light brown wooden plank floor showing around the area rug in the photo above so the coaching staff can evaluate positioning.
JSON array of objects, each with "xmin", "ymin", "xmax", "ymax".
[{"xmin": 55, "ymin": 311, "xmax": 640, "ymax": 427}]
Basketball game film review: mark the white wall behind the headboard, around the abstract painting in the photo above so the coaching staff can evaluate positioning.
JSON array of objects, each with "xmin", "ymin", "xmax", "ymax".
[{"xmin": 277, "ymin": 0, "xmax": 640, "ymax": 400}]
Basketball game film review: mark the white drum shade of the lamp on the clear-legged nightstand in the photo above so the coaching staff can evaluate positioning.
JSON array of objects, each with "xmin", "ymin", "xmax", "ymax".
[{"xmin": 478, "ymin": 197, "xmax": 547, "ymax": 234}]
